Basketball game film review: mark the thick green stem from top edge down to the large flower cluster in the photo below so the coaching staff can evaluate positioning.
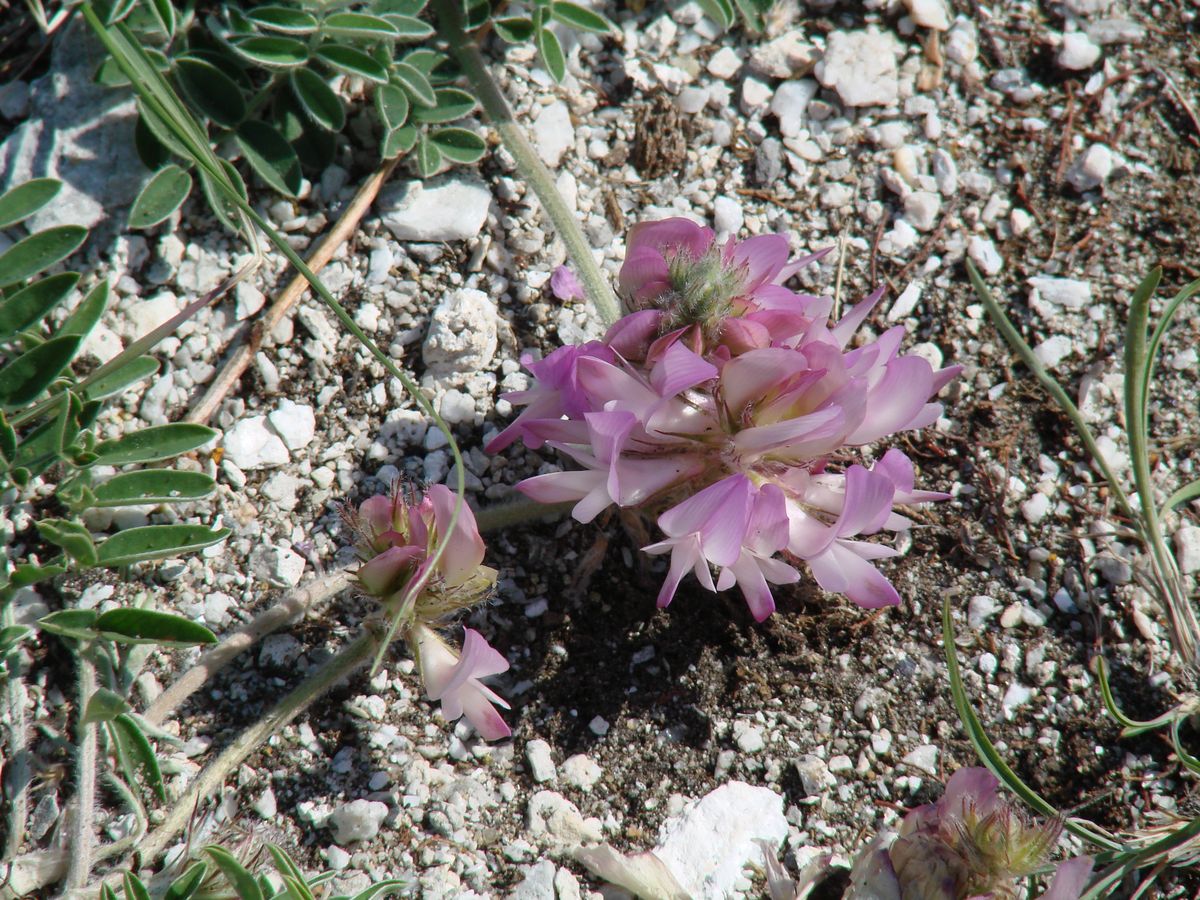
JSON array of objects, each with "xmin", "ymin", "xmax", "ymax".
[{"xmin": 433, "ymin": 0, "xmax": 620, "ymax": 325}]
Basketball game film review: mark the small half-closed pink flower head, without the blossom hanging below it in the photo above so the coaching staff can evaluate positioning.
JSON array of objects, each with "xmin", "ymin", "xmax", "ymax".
[{"xmin": 347, "ymin": 485, "xmax": 496, "ymax": 620}]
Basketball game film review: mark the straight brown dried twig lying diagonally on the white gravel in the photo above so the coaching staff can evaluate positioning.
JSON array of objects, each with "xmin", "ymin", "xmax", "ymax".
[{"xmin": 186, "ymin": 160, "xmax": 398, "ymax": 425}]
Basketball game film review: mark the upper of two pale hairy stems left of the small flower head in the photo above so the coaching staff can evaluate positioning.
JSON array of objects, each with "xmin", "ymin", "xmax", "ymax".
[{"xmin": 142, "ymin": 571, "xmax": 350, "ymax": 725}]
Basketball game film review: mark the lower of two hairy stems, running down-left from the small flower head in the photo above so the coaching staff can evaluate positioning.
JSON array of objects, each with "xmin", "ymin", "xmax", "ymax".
[{"xmin": 129, "ymin": 626, "xmax": 379, "ymax": 862}]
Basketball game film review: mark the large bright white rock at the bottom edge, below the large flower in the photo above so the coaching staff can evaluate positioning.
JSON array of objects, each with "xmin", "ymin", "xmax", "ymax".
[{"xmin": 654, "ymin": 781, "xmax": 787, "ymax": 900}]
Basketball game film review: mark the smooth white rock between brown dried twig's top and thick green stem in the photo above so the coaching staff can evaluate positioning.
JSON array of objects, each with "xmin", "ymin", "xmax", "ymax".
[{"xmin": 377, "ymin": 175, "xmax": 492, "ymax": 241}]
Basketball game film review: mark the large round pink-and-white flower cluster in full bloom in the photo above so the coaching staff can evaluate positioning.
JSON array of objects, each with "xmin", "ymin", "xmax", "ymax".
[{"xmin": 488, "ymin": 218, "xmax": 959, "ymax": 620}]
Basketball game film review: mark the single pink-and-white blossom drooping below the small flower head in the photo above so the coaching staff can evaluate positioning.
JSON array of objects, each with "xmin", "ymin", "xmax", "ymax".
[{"xmin": 413, "ymin": 625, "xmax": 512, "ymax": 740}]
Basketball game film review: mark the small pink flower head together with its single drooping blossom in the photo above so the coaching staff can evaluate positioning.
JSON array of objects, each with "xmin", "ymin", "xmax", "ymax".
[{"xmin": 347, "ymin": 485, "xmax": 510, "ymax": 740}]
